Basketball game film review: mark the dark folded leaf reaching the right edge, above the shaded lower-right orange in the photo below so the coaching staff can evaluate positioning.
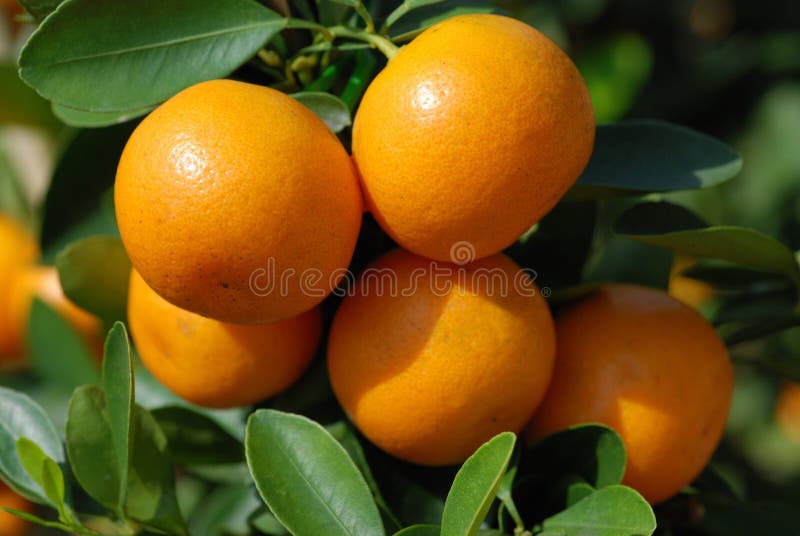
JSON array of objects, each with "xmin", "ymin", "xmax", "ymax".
[{"xmin": 614, "ymin": 202, "xmax": 800, "ymax": 294}]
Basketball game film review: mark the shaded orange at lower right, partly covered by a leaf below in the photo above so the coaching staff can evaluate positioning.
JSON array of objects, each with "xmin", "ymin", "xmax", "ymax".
[{"xmin": 527, "ymin": 285, "xmax": 733, "ymax": 503}]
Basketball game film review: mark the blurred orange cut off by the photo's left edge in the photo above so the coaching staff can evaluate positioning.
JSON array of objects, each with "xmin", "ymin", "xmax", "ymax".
[{"xmin": 0, "ymin": 214, "xmax": 39, "ymax": 362}]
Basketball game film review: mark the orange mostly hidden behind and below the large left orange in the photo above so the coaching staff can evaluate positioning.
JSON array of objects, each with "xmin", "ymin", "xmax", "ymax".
[{"xmin": 128, "ymin": 270, "xmax": 322, "ymax": 408}]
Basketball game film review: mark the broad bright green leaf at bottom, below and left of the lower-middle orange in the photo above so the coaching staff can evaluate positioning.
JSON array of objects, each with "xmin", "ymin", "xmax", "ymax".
[{"xmin": 245, "ymin": 410, "xmax": 384, "ymax": 536}]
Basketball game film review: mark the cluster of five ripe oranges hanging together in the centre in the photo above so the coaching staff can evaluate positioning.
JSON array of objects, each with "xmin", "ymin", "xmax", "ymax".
[{"xmin": 109, "ymin": 15, "xmax": 733, "ymax": 502}]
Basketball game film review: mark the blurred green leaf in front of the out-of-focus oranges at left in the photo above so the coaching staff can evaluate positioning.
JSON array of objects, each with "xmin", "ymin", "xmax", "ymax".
[{"xmin": 28, "ymin": 299, "xmax": 99, "ymax": 391}]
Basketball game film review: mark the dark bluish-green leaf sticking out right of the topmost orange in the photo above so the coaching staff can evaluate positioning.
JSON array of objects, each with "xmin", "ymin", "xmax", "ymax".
[{"xmin": 570, "ymin": 120, "xmax": 742, "ymax": 197}]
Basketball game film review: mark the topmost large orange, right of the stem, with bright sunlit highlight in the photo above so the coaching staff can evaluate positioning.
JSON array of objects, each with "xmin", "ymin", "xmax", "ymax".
[{"xmin": 353, "ymin": 15, "xmax": 595, "ymax": 261}]
